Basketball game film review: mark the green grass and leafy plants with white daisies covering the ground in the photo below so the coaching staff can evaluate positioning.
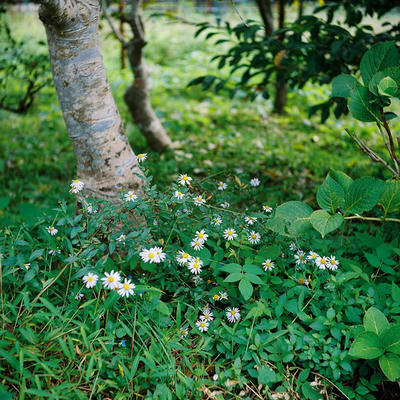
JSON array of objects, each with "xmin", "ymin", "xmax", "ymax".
[{"xmin": 0, "ymin": 1, "xmax": 400, "ymax": 400}]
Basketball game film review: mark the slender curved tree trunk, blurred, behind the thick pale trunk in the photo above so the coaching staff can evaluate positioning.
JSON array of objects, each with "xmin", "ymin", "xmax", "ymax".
[{"xmin": 124, "ymin": 0, "xmax": 171, "ymax": 151}]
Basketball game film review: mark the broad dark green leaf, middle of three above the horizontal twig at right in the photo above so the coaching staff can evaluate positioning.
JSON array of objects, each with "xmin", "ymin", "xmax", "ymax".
[{"xmin": 344, "ymin": 176, "xmax": 385, "ymax": 215}]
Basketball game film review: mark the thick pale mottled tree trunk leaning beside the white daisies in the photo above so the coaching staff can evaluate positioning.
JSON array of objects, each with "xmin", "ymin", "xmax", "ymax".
[{"xmin": 39, "ymin": 0, "xmax": 141, "ymax": 203}]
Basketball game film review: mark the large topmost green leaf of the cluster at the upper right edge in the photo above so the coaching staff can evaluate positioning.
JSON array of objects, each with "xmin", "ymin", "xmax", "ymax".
[{"xmin": 360, "ymin": 42, "xmax": 400, "ymax": 85}]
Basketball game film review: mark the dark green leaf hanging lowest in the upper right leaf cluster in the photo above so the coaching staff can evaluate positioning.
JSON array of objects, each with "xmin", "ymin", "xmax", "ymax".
[{"xmin": 349, "ymin": 86, "xmax": 381, "ymax": 122}]
